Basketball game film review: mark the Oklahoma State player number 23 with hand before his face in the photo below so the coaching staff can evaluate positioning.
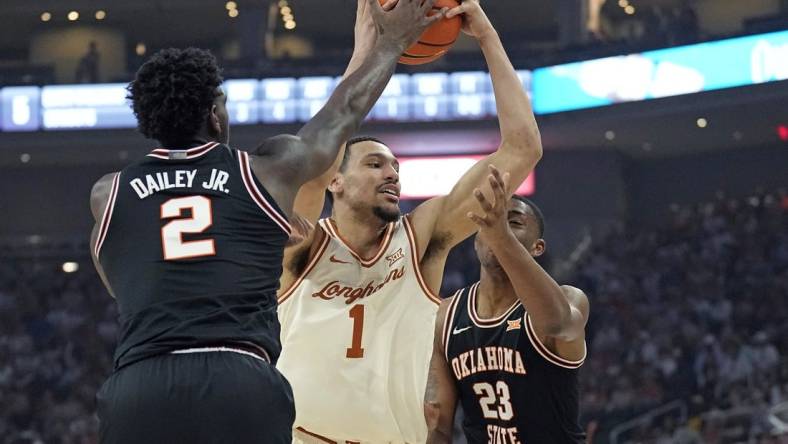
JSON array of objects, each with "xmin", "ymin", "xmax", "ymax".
[{"xmin": 424, "ymin": 167, "xmax": 588, "ymax": 444}]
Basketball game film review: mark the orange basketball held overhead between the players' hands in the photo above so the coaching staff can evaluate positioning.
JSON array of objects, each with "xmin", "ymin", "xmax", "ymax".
[{"xmin": 380, "ymin": 0, "xmax": 462, "ymax": 65}]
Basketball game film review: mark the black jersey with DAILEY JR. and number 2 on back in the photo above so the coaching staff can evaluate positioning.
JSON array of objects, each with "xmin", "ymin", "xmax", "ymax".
[{"xmin": 94, "ymin": 142, "xmax": 290, "ymax": 369}]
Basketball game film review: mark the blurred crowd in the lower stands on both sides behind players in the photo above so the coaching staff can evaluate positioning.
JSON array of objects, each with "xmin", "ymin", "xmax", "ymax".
[{"xmin": 0, "ymin": 189, "xmax": 788, "ymax": 444}]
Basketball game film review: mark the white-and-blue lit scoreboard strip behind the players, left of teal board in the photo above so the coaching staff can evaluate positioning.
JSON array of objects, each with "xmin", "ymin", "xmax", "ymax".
[{"xmin": 0, "ymin": 71, "xmax": 531, "ymax": 131}]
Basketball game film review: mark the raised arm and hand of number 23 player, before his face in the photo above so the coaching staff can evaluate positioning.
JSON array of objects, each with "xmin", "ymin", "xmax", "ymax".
[{"xmin": 467, "ymin": 166, "xmax": 588, "ymax": 346}]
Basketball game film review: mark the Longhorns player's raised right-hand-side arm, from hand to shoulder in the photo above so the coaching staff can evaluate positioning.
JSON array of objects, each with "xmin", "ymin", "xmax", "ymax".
[{"xmin": 412, "ymin": 0, "xmax": 542, "ymax": 257}]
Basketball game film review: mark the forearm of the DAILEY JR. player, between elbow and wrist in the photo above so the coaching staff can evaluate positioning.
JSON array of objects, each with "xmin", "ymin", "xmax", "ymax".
[{"xmin": 298, "ymin": 43, "xmax": 401, "ymax": 172}]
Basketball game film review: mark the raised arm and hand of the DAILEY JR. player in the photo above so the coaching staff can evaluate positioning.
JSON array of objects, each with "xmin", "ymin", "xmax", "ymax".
[{"xmin": 252, "ymin": 0, "xmax": 443, "ymax": 214}]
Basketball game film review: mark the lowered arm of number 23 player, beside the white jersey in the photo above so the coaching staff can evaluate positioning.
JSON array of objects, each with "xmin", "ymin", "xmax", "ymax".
[{"xmin": 424, "ymin": 298, "xmax": 457, "ymax": 444}]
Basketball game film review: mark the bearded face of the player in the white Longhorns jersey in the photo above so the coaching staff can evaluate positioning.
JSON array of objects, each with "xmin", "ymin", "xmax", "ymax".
[{"xmin": 334, "ymin": 141, "xmax": 401, "ymax": 222}]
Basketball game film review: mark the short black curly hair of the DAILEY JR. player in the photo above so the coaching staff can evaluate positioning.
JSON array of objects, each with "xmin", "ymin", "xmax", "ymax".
[{"xmin": 126, "ymin": 48, "xmax": 223, "ymax": 144}]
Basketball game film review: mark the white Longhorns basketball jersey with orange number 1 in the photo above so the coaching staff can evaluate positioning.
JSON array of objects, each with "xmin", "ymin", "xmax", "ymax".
[{"xmin": 277, "ymin": 217, "xmax": 440, "ymax": 443}]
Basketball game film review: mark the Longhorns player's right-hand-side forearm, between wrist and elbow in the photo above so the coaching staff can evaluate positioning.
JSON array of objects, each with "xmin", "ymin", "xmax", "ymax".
[{"xmin": 479, "ymin": 27, "xmax": 542, "ymax": 153}]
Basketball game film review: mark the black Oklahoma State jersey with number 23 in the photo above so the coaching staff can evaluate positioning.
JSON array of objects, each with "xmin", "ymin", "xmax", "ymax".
[{"xmin": 443, "ymin": 283, "xmax": 585, "ymax": 444}]
